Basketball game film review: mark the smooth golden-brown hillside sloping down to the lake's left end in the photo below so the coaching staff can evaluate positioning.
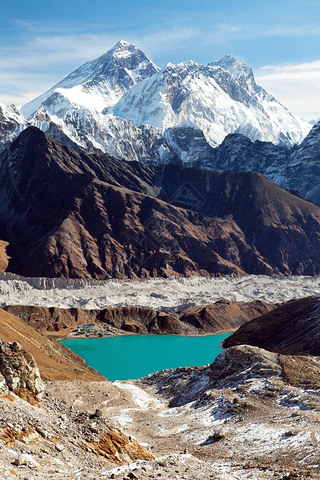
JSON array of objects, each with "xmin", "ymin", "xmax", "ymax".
[{"xmin": 0, "ymin": 309, "xmax": 102, "ymax": 381}]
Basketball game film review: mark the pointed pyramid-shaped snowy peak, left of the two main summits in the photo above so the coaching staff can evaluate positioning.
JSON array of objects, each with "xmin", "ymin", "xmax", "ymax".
[{"xmin": 21, "ymin": 40, "xmax": 159, "ymax": 119}]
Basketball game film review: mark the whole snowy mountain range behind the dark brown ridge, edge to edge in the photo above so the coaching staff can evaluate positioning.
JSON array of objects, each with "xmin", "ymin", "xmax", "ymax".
[{"xmin": 0, "ymin": 41, "xmax": 320, "ymax": 204}]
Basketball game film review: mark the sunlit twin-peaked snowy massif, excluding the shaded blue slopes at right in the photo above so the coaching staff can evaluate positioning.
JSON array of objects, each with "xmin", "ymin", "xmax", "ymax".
[{"xmin": 16, "ymin": 41, "xmax": 311, "ymax": 164}]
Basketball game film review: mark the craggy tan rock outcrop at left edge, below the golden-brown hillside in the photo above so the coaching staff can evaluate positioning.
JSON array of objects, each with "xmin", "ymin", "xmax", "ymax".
[{"xmin": 0, "ymin": 340, "xmax": 44, "ymax": 401}]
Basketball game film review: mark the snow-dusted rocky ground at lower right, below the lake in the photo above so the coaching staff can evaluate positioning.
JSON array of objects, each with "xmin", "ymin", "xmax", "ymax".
[{"xmin": 48, "ymin": 346, "xmax": 319, "ymax": 480}]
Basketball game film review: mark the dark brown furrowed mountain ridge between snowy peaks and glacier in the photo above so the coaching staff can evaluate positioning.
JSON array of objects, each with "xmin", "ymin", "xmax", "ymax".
[{"xmin": 0, "ymin": 128, "xmax": 320, "ymax": 279}]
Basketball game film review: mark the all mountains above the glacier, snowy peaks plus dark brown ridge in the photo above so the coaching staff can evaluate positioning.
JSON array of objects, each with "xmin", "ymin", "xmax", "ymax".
[{"xmin": 0, "ymin": 41, "xmax": 320, "ymax": 279}]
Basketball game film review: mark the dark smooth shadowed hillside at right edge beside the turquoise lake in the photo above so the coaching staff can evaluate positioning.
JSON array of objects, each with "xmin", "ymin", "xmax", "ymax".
[{"xmin": 223, "ymin": 297, "xmax": 320, "ymax": 355}]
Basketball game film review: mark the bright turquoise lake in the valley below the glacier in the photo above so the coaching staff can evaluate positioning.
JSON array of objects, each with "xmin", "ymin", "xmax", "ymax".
[{"xmin": 61, "ymin": 333, "xmax": 230, "ymax": 380}]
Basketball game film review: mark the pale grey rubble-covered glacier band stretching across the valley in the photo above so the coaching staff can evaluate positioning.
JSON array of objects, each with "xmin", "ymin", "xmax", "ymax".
[{"xmin": 0, "ymin": 273, "xmax": 320, "ymax": 310}]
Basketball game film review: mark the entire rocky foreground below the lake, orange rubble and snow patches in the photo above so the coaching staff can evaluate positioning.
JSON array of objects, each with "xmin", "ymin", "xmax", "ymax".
[{"xmin": 0, "ymin": 340, "xmax": 320, "ymax": 480}]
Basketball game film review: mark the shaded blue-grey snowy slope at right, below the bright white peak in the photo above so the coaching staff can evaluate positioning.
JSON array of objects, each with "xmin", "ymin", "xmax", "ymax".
[{"xmin": 189, "ymin": 122, "xmax": 320, "ymax": 205}]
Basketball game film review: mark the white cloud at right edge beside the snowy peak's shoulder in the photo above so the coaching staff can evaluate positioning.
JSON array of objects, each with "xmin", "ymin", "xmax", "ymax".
[{"xmin": 256, "ymin": 60, "xmax": 320, "ymax": 121}]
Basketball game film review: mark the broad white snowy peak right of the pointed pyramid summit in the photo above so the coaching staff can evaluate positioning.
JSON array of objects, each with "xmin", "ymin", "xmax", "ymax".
[{"xmin": 113, "ymin": 56, "xmax": 310, "ymax": 146}]
